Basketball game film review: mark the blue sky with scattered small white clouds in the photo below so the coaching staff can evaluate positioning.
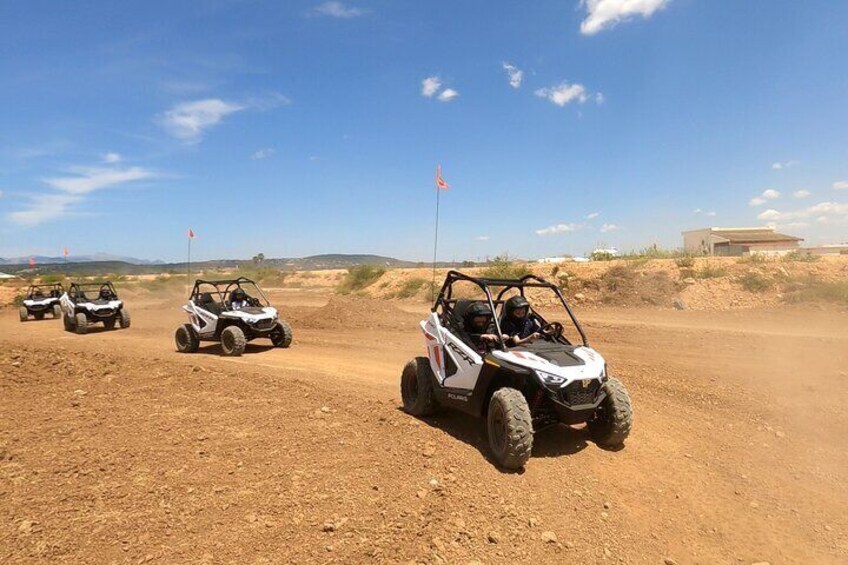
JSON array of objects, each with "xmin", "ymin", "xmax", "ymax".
[{"xmin": 0, "ymin": 0, "xmax": 848, "ymax": 260}]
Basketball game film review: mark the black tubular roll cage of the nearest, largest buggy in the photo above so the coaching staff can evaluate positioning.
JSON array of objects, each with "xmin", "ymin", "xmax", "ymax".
[{"xmin": 430, "ymin": 271, "xmax": 589, "ymax": 351}]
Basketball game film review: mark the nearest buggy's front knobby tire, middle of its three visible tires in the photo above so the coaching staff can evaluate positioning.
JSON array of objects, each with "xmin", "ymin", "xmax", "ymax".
[{"xmin": 486, "ymin": 388, "xmax": 533, "ymax": 469}]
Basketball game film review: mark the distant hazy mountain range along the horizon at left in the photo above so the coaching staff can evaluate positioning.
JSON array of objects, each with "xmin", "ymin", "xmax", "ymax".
[{"xmin": 0, "ymin": 253, "xmax": 455, "ymax": 276}]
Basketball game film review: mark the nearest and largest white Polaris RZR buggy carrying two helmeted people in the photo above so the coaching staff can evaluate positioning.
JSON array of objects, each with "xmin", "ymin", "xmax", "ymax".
[{"xmin": 401, "ymin": 271, "xmax": 632, "ymax": 469}]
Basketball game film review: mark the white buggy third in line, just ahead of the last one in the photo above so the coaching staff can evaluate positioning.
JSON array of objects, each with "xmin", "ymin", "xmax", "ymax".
[{"xmin": 59, "ymin": 281, "xmax": 130, "ymax": 334}]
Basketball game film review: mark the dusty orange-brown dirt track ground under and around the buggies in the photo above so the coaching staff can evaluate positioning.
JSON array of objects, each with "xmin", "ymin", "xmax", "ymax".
[{"xmin": 0, "ymin": 291, "xmax": 848, "ymax": 565}]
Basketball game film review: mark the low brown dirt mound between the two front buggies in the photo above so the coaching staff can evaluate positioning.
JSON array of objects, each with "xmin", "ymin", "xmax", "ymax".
[{"xmin": 291, "ymin": 297, "xmax": 420, "ymax": 330}]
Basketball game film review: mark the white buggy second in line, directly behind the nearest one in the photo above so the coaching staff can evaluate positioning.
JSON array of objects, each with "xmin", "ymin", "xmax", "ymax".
[{"xmin": 174, "ymin": 277, "xmax": 292, "ymax": 356}]
